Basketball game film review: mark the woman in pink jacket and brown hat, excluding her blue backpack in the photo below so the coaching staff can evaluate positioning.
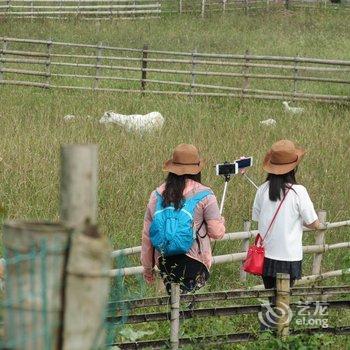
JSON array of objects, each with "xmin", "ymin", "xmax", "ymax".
[{"xmin": 141, "ymin": 144, "xmax": 225, "ymax": 292}]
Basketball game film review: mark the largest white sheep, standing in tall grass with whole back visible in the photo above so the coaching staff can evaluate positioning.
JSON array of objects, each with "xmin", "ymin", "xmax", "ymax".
[{"xmin": 100, "ymin": 112, "xmax": 164, "ymax": 132}]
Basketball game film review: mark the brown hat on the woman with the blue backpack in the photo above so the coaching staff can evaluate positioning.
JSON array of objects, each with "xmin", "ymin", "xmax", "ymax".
[{"xmin": 163, "ymin": 143, "xmax": 203, "ymax": 175}]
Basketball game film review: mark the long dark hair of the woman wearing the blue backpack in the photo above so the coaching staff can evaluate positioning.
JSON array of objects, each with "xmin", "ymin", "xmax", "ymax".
[{"xmin": 163, "ymin": 172, "xmax": 201, "ymax": 209}]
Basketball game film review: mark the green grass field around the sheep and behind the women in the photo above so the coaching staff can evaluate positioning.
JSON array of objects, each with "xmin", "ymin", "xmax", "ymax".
[{"xmin": 0, "ymin": 6, "xmax": 350, "ymax": 347}]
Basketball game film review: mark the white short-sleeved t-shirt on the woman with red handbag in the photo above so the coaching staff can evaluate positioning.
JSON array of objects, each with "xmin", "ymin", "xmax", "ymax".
[{"xmin": 252, "ymin": 182, "xmax": 317, "ymax": 261}]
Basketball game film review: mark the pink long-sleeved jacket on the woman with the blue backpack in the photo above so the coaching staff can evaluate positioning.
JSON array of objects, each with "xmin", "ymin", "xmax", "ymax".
[{"xmin": 141, "ymin": 179, "xmax": 225, "ymax": 282}]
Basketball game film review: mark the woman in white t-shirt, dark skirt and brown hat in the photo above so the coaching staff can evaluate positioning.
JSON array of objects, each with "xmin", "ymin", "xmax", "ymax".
[{"xmin": 252, "ymin": 140, "xmax": 320, "ymax": 329}]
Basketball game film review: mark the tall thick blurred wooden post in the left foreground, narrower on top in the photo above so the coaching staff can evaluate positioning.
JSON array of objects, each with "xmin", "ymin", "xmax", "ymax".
[{"xmin": 60, "ymin": 145, "xmax": 111, "ymax": 350}]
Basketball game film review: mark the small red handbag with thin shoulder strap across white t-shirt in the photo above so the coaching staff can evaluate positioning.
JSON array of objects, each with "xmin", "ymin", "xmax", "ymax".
[{"xmin": 243, "ymin": 186, "xmax": 293, "ymax": 276}]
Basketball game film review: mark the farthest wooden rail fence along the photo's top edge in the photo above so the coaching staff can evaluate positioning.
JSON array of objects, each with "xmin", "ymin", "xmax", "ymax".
[{"xmin": 0, "ymin": 0, "xmax": 349, "ymax": 19}]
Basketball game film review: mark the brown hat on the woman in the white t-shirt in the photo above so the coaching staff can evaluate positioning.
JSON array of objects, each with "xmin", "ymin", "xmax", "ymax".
[{"xmin": 263, "ymin": 140, "xmax": 305, "ymax": 175}]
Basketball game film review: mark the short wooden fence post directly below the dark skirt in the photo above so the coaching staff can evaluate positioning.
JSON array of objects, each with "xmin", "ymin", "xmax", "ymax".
[{"xmin": 276, "ymin": 273, "xmax": 291, "ymax": 338}]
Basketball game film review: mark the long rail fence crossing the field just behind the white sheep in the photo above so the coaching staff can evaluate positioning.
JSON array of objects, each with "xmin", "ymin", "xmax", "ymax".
[{"xmin": 0, "ymin": 37, "xmax": 350, "ymax": 103}]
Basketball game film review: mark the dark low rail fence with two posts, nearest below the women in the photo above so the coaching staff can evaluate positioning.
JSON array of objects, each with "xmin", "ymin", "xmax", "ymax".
[{"xmin": 107, "ymin": 280, "xmax": 350, "ymax": 350}]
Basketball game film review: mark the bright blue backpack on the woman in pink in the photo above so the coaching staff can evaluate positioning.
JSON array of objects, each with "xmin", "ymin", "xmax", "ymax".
[{"xmin": 149, "ymin": 190, "xmax": 212, "ymax": 256}]
